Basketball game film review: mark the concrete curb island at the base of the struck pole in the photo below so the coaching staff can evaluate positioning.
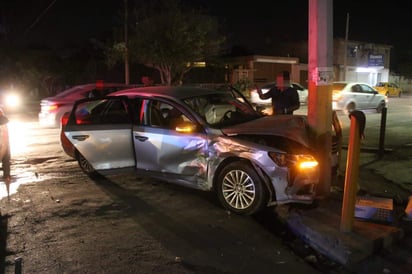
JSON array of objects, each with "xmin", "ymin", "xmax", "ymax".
[{"xmin": 276, "ymin": 195, "xmax": 404, "ymax": 268}]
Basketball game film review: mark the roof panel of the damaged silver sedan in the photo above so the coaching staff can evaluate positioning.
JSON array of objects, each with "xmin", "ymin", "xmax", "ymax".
[{"xmin": 108, "ymin": 86, "xmax": 227, "ymax": 100}]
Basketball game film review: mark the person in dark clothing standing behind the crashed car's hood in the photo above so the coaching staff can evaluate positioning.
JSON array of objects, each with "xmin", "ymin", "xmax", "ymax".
[{"xmin": 257, "ymin": 71, "xmax": 300, "ymax": 115}]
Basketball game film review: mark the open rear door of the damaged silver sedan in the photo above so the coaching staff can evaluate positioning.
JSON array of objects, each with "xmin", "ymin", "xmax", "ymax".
[{"xmin": 64, "ymin": 96, "xmax": 135, "ymax": 171}]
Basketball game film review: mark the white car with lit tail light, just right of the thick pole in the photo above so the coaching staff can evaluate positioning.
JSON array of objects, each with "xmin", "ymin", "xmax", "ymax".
[{"xmin": 332, "ymin": 82, "xmax": 387, "ymax": 113}]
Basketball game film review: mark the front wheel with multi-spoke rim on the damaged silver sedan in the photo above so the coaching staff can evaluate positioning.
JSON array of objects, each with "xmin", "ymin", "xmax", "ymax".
[{"xmin": 216, "ymin": 161, "xmax": 268, "ymax": 215}]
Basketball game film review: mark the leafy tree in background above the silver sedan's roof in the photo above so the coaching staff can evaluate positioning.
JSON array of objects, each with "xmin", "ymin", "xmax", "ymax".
[{"xmin": 104, "ymin": 0, "xmax": 224, "ymax": 85}]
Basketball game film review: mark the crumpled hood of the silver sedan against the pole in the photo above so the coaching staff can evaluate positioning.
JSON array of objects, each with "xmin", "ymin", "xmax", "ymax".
[{"xmin": 221, "ymin": 115, "xmax": 311, "ymax": 147}]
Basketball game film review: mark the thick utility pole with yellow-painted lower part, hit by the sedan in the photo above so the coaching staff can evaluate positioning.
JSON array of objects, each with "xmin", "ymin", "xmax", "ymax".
[{"xmin": 308, "ymin": 0, "xmax": 333, "ymax": 195}]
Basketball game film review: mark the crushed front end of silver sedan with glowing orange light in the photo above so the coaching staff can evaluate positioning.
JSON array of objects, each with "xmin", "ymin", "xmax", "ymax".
[{"xmin": 219, "ymin": 115, "xmax": 320, "ymax": 205}]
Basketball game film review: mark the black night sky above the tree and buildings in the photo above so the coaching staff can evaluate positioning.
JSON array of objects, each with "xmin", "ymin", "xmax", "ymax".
[{"xmin": 0, "ymin": 0, "xmax": 412, "ymax": 59}]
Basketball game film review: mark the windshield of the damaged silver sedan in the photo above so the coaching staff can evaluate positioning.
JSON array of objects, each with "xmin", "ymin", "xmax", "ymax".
[{"xmin": 183, "ymin": 92, "xmax": 262, "ymax": 128}]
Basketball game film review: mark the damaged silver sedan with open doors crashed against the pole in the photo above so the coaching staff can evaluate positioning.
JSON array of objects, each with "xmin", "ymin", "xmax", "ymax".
[{"xmin": 61, "ymin": 86, "xmax": 328, "ymax": 215}]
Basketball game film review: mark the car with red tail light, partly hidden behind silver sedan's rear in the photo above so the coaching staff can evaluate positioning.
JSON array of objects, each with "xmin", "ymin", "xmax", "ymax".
[{"xmin": 39, "ymin": 82, "xmax": 135, "ymax": 127}]
